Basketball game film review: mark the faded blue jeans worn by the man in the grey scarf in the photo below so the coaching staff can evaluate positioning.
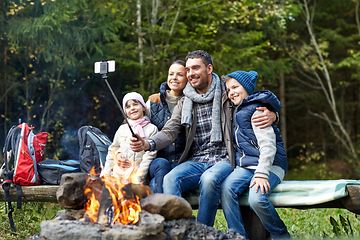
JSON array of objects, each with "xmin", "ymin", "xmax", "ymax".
[{"xmin": 163, "ymin": 161, "xmax": 232, "ymax": 226}]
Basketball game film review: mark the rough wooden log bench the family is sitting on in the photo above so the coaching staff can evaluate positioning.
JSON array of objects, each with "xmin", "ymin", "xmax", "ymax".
[{"xmin": 0, "ymin": 181, "xmax": 360, "ymax": 240}]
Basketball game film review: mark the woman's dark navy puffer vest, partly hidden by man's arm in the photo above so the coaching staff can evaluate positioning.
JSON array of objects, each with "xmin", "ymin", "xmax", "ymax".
[{"xmin": 150, "ymin": 82, "xmax": 186, "ymax": 162}]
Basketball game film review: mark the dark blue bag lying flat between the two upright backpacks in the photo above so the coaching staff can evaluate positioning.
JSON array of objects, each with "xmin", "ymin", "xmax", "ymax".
[{"xmin": 38, "ymin": 159, "xmax": 80, "ymax": 185}]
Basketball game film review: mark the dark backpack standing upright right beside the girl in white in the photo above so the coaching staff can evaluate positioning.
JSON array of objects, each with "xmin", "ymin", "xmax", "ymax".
[{"xmin": 78, "ymin": 126, "xmax": 111, "ymax": 174}]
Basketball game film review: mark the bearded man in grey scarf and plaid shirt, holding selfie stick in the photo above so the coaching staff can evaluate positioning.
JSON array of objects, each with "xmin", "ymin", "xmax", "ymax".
[{"xmin": 131, "ymin": 50, "xmax": 276, "ymax": 226}]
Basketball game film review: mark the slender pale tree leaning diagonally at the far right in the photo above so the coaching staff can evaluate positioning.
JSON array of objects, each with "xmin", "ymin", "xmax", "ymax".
[{"xmin": 291, "ymin": 0, "xmax": 357, "ymax": 159}]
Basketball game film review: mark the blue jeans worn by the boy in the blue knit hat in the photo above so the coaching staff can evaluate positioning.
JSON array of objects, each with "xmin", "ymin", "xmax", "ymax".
[{"xmin": 221, "ymin": 167, "xmax": 290, "ymax": 239}]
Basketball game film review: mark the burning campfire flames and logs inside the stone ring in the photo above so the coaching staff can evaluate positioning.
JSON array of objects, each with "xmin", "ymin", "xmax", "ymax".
[{"xmin": 84, "ymin": 168, "xmax": 151, "ymax": 225}]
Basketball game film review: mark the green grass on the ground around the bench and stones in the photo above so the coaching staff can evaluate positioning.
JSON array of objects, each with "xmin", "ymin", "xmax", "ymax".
[{"xmin": 0, "ymin": 203, "xmax": 360, "ymax": 240}]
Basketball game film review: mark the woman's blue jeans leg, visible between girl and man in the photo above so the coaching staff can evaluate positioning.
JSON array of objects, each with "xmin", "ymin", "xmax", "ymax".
[{"xmin": 149, "ymin": 158, "xmax": 178, "ymax": 193}]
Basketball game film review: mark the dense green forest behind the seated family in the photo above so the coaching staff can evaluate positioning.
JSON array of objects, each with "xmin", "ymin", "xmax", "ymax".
[{"xmin": 0, "ymin": 0, "xmax": 360, "ymax": 179}]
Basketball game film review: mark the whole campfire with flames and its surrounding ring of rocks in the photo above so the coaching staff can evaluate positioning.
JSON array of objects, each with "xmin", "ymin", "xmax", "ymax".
[{"xmin": 40, "ymin": 173, "xmax": 243, "ymax": 240}]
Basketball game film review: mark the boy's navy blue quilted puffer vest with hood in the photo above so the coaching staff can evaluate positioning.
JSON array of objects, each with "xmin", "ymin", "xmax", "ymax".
[{"xmin": 235, "ymin": 90, "xmax": 288, "ymax": 172}]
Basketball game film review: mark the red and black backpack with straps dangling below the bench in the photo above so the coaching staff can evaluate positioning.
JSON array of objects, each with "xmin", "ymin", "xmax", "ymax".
[{"xmin": 0, "ymin": 123, "xmax": 48, "ymax": 231}]
